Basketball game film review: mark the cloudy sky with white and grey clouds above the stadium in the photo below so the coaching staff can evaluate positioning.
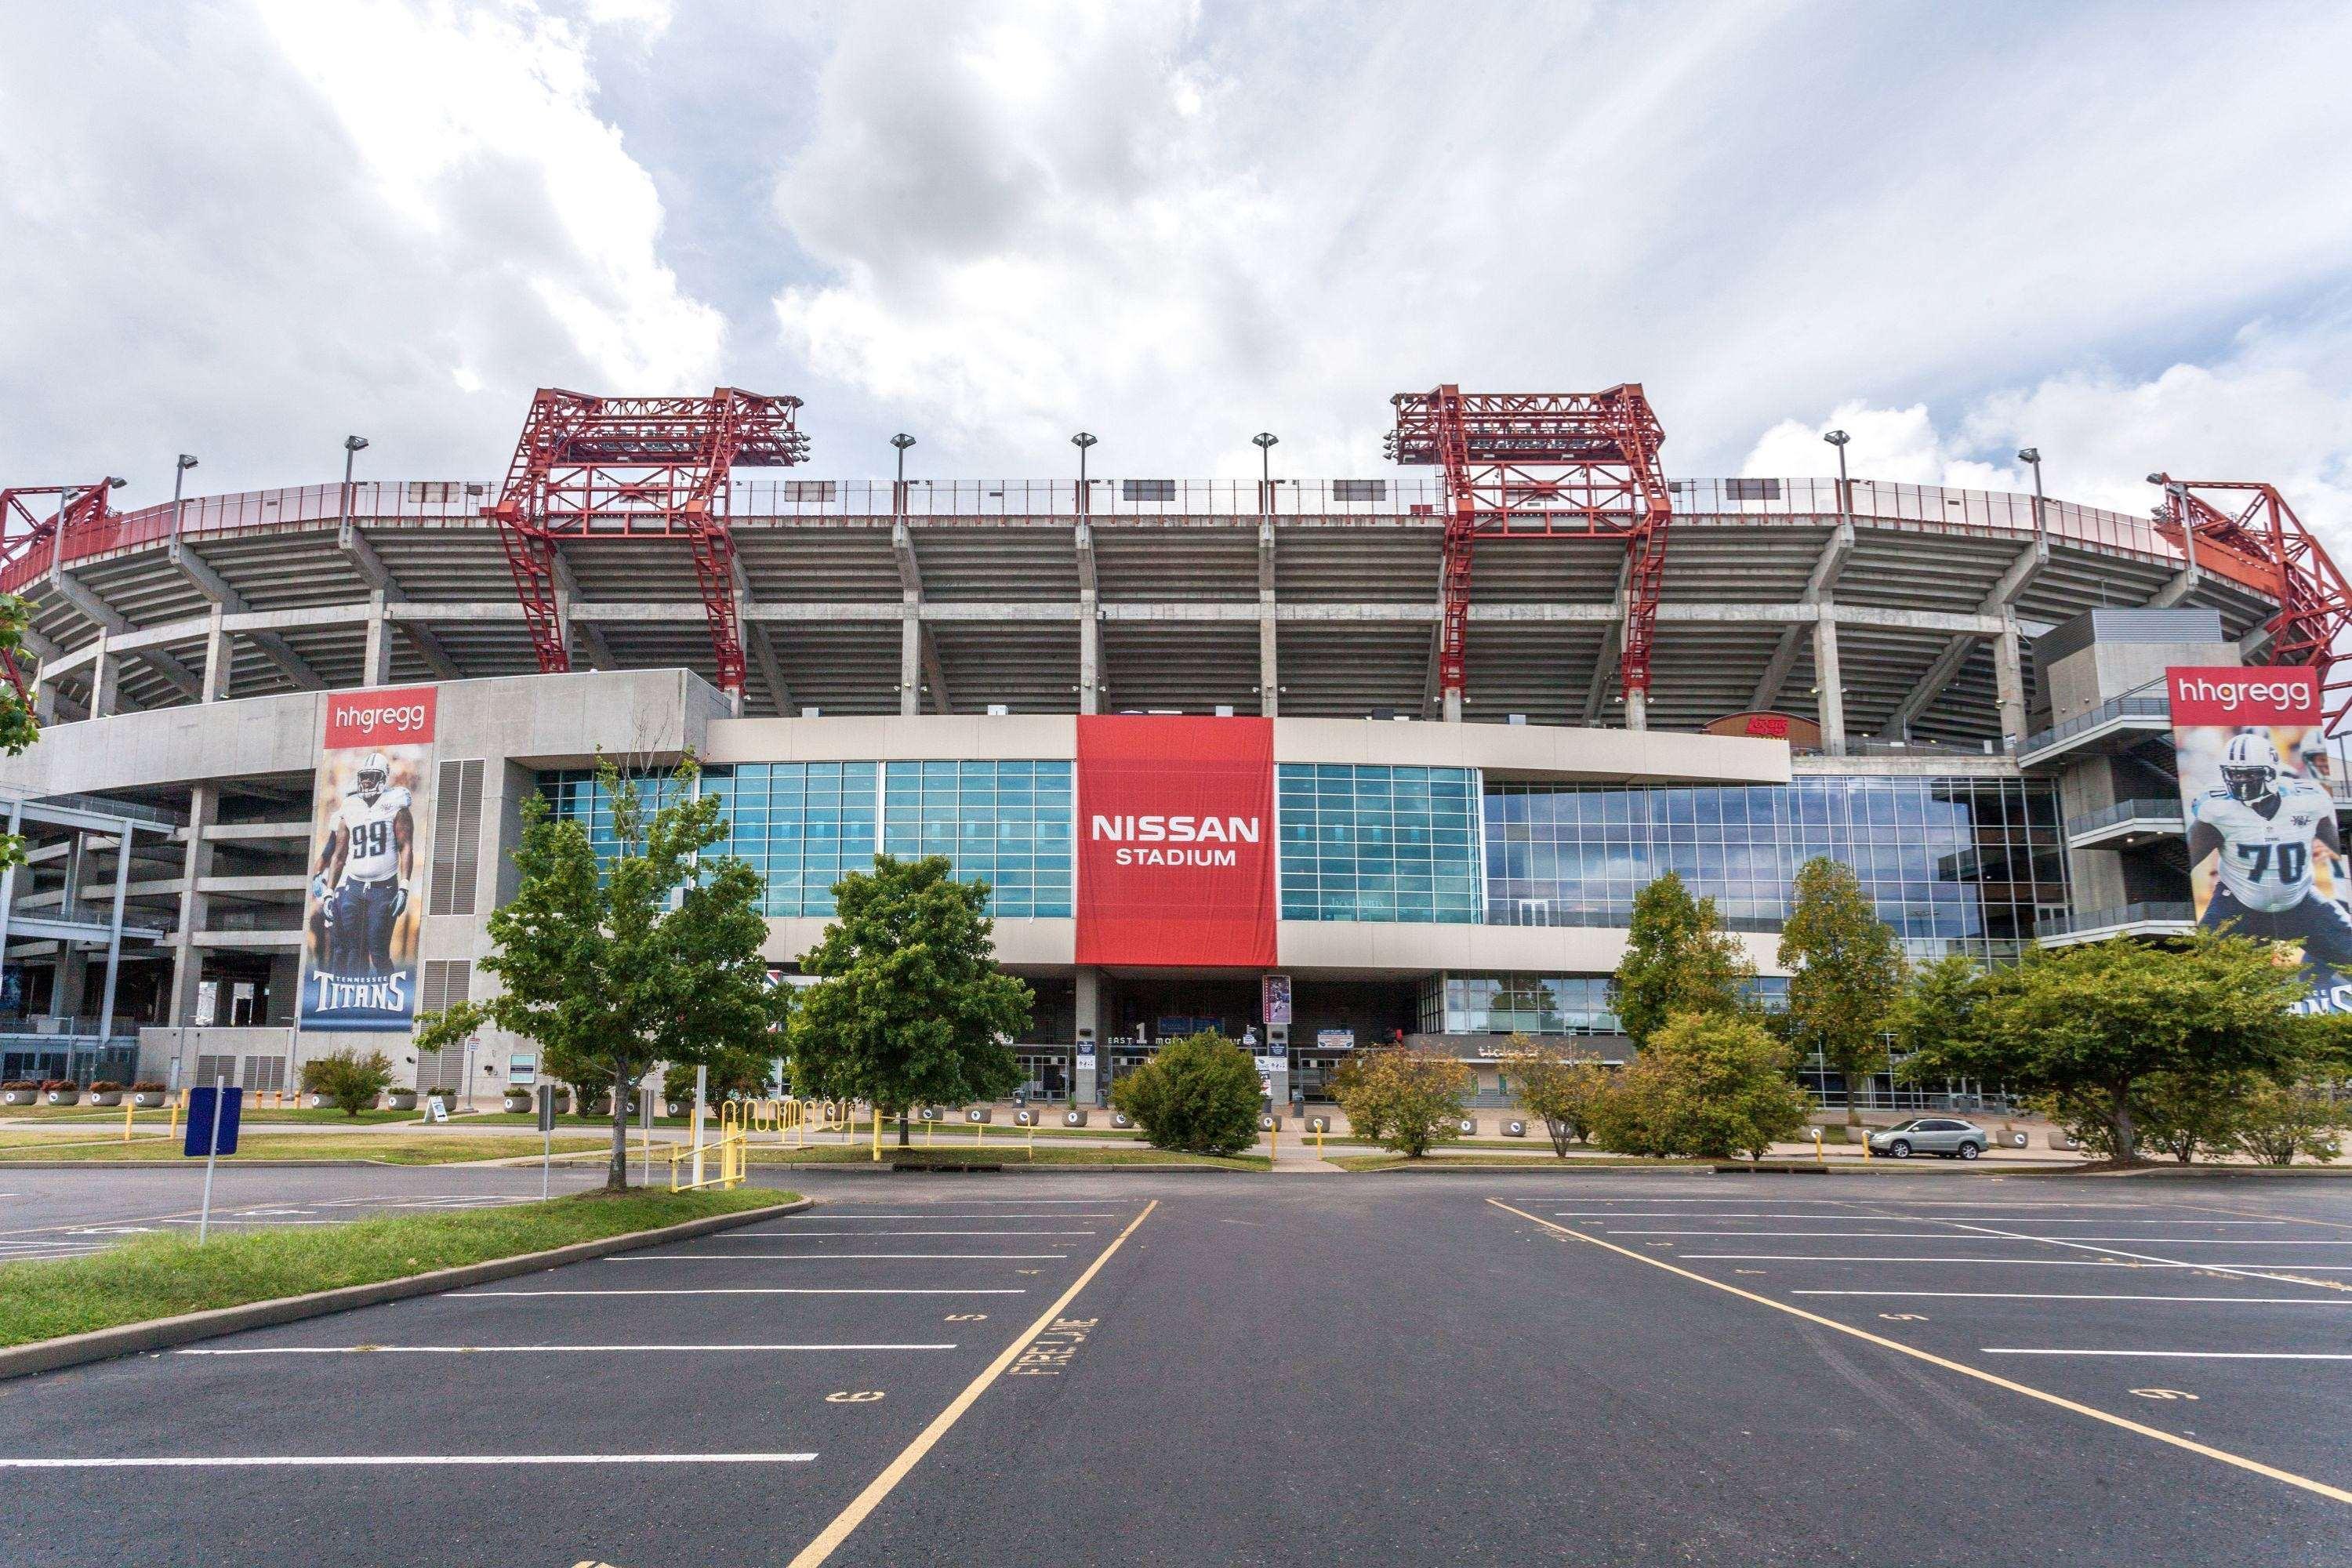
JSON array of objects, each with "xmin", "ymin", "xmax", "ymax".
[{"xmin": 0, "ymin": 0, "xmax": 2352, "ymax": 541}]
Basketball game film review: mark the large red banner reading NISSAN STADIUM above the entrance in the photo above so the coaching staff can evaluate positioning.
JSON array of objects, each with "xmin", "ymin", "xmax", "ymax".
[{"xmin": 1077, "ymin": 715, "xmax": 1275, "ymax": 968}]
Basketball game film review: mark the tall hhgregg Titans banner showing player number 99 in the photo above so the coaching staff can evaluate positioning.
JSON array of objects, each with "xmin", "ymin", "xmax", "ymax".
[{"xmin": 301, "ymin": 687, "xmax": 435, "ymax": 1029}]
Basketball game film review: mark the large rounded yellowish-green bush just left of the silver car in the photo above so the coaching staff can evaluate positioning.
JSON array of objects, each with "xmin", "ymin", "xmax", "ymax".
[{"xmin": 1592, "ymin": 1013, "xmax": 1811, "ymax": 1159}]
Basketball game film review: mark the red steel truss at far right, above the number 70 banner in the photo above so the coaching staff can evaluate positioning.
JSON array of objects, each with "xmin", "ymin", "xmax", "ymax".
[{"xmin": 2147, "ymin": 473, "xmax": 2352, "ymax": 734}]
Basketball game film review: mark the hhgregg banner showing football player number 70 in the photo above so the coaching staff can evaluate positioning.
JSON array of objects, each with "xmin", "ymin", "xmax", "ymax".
[{"xmin": 2164, "ymin": 668, "xmax": 2352, "ymax": 1013}]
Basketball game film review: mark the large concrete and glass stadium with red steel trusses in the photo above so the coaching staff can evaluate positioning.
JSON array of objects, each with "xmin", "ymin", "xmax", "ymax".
[{"xmin": 0, "ymin": 386, "xmax": 2347, "ymax": 1100}]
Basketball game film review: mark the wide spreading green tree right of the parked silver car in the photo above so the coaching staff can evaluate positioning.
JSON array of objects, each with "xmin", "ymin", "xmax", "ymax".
[{"xmin": 1896, "ymin": 931, "xmax": 2307, "ymax": 1163}]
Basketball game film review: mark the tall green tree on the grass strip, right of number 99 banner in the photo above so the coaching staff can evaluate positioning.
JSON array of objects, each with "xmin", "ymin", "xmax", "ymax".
[{"xmin": 416, "ymin": 757, "xmax": 793, "ymax": 1189}]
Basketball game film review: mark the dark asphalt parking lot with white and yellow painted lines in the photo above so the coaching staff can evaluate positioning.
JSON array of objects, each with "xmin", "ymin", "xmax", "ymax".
[{"xmin": 0, "ymin": 1171, "xmax": 2352, "ymax": 1568}]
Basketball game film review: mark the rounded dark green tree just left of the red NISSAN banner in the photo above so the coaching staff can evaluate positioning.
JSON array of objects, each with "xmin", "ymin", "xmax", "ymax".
[{"xmin": 790, "ymin": 855, "xmax": 1033, "ymax": 1147}]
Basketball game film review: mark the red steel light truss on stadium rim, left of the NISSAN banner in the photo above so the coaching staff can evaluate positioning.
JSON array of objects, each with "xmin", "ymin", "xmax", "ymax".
[{"xmin": 482, "ymin": 386, "xmax": 809, "ymax": 696}]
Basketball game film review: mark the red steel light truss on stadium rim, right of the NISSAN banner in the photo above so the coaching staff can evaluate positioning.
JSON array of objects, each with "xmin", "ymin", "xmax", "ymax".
[{"xmin": 1388, "ymin": 383, "xmax": 1670, "ymax": 714}]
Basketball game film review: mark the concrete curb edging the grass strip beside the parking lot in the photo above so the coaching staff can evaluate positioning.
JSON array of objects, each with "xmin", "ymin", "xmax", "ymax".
[{"xmin": 0, "ymin": 1199, "xmax": 816, "ymax": 1382}]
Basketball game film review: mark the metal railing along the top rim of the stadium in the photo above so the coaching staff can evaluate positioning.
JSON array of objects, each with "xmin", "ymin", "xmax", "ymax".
[{"xmin": 0, "ymin": 473, "xmax": 2180, "ymax": 593}]
